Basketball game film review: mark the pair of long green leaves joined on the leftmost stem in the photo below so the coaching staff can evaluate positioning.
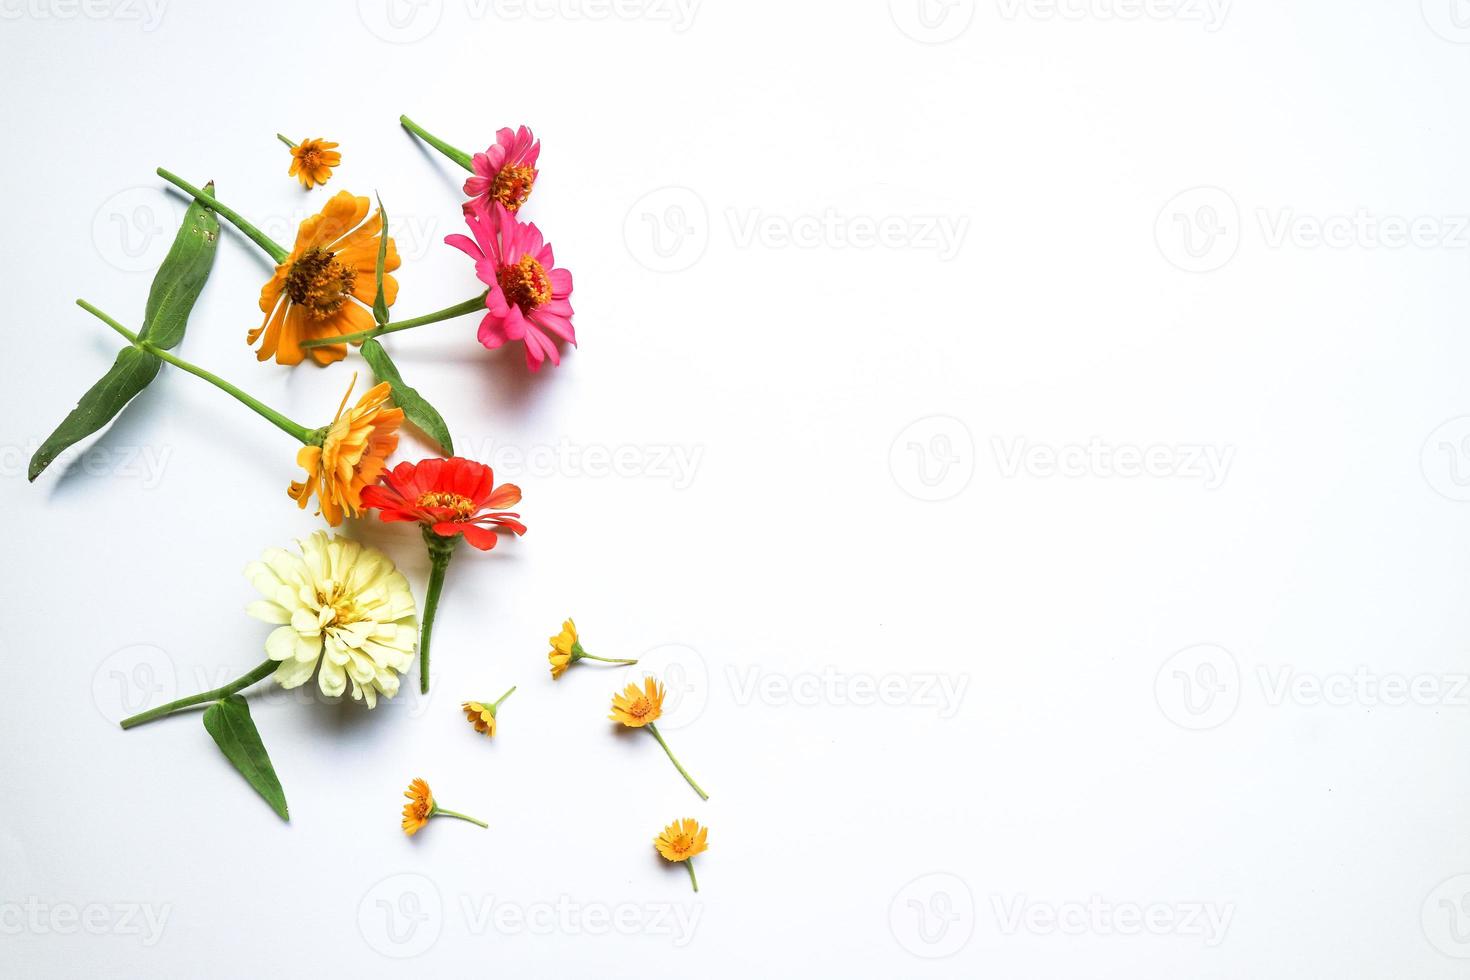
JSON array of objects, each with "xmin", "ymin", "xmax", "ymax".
[{"xmin": 26, "ymin": 184, "xmax": 219, "ymax": 480}]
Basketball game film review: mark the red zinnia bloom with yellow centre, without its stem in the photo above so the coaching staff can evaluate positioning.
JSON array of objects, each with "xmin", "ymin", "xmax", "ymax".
[{"xmin": 362, "ymin": 455, "xmax": 526, "ymax": 551}]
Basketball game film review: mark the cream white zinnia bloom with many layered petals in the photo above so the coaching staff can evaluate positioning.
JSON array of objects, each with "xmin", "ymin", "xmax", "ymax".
[{"xmin": 245, "ymin": 530, "xmax": 419, "ymax": 708}]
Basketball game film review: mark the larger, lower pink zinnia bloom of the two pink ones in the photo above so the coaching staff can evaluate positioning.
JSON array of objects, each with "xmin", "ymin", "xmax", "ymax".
[{"xmin": 444, "ymin": 201, "xmax": 576, "ymax": 370}]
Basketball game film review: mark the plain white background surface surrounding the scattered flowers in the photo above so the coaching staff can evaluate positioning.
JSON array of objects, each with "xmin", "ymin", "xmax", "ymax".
[{"xmin": 0, "ymin": 0, "xmax": 1470, "ymax": 979}]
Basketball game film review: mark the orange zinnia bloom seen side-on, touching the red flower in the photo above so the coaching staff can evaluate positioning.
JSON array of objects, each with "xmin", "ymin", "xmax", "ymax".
[{"xmin": 287, "ymin": 378, "xmax": 403, "ymax": 527}]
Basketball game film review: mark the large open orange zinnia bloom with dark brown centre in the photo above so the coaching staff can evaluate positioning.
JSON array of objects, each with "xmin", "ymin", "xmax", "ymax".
[{"xmin": 247, "ymin": 191, "xmax": 403, "ymax": 364}]
